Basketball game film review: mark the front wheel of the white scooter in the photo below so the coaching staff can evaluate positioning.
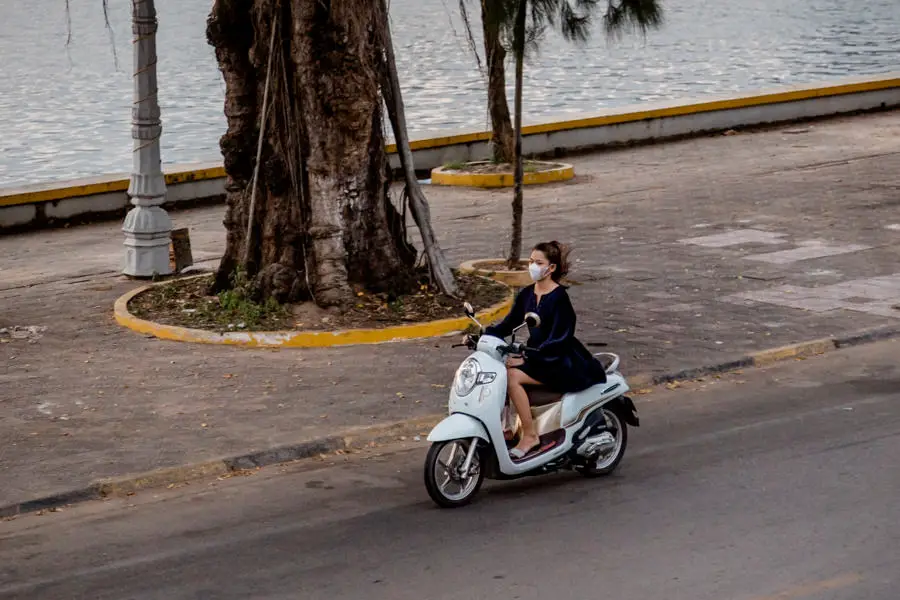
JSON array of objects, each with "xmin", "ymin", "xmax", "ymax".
[{"xmin": 425, "ymin": 440, "xmax": 484, "ymax": 508}]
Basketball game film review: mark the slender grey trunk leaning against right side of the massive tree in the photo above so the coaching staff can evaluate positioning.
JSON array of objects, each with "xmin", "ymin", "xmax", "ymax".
[{"xmin": 379, "ymin": 0, "xmax": 459, "ymax": 296}]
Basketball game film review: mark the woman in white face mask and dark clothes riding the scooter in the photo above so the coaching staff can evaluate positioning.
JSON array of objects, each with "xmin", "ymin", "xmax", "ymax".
[{"xmin": 485, "ymin": 241, "xmax": 606, "ymax": 460}]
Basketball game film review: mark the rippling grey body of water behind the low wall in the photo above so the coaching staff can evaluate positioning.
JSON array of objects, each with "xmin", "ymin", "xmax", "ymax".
[{"xmin": 0, "ymin": 0, "xmax": 900, "ymax": 186}]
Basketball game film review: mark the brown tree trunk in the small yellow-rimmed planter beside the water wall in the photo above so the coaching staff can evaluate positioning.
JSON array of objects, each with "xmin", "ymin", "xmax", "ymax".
[{"xmin": 481, "ymin": 0, "xmax": 515, "ymax": 163}]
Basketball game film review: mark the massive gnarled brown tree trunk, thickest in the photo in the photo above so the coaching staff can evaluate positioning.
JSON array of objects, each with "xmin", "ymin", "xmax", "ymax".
[{"xmin": 207, "ymin": 0, "xmax": 416, "ymax": 306}]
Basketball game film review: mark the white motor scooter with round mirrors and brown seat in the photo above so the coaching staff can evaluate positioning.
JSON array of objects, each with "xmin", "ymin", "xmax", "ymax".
[{"xmin": 425, "ymin": 302, "xmax": 639, "ymax": 508}]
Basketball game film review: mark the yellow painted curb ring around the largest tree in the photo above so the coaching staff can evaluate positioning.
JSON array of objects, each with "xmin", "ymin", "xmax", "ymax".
[{"xmin": 113, "ymin": 275, "xmax": 513, "ymax": 348}]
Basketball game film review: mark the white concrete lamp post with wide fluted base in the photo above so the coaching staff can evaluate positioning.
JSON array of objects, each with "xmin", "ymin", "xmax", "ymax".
[{"xmin": 122, "ymin": 0, "xmax": 172, "ymax": 277}]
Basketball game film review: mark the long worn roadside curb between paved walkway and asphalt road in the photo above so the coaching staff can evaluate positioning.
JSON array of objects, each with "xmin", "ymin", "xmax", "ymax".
[{"xmin": 0, "ymin": 325, "xmax": 900, "ymax": 518}]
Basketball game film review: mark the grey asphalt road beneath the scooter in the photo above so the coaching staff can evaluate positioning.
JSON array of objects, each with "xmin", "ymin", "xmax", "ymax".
[{"xmin": 0, "ymin": 342, "xmax": 900, "ymax": 600}]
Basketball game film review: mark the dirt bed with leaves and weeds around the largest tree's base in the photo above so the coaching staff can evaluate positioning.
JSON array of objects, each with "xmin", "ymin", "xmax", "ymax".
[{"xmin": 128, "ymin": 273, "xmax": 509, "ymax": 332}]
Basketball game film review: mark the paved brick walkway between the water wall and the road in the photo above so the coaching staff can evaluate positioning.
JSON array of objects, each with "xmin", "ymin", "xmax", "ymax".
[{"xmin": 0, "ymin": 111, "xmax": 900, "ymax": 505}]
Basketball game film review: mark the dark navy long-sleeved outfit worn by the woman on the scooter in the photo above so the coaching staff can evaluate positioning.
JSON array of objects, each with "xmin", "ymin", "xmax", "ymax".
[{"xmin": 485, "ymin": 285, "xmax": 606, "ymax": 393}]
